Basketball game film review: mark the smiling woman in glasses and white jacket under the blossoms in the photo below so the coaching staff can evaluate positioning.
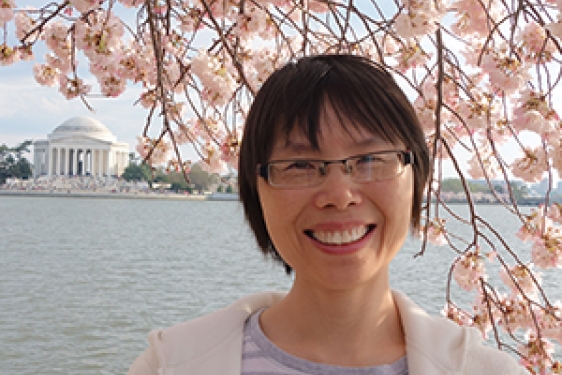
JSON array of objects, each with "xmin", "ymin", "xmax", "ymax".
[{"xmin": 124, "ymin": 55, "xmax": 526, "ymax": 375}]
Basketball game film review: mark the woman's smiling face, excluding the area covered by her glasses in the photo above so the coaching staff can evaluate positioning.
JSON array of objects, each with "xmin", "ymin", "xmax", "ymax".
[{"xmin": 258, "ymin": 108, "xmax": 413, "ymax": 290}]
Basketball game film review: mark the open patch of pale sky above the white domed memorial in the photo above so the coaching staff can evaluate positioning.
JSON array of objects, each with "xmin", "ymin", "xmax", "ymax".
[{"xmin": 0, "ymin": 56, "xmax": 146, "ymax": 156}]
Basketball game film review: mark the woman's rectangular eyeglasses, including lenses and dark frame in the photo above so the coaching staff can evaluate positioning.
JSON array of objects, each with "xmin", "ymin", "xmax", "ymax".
[{"xmin": 257, "ymin": 150, "xmax": 414, "ymax": 188}]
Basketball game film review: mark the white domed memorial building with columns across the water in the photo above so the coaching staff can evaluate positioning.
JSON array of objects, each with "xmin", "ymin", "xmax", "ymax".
[{"xmin": 33, "ymin": 117, "xmax": 129, "ymax": 177}]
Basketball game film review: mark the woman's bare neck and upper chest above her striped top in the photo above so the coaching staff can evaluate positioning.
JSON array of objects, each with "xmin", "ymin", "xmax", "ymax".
[{"xmin": 260, "ymin": 279, "xmax": 405, "ymax": 367}]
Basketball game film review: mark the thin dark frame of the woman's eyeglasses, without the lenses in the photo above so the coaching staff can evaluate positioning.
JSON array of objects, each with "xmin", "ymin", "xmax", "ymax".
[{"xmin": 257, "ymin": 150, "xmax": 414, "ymax": 189}]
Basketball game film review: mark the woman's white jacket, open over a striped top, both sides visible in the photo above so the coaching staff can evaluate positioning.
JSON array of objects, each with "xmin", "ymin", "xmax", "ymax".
[{"xmin": 127, "ymin": 291, "xmax": 528, "ymax": 375}]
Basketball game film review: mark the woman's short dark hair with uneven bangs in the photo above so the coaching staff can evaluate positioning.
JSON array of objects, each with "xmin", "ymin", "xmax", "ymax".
[{"xmin": 238, "ymin": 55, "xmax": 430, "ymax": 273}]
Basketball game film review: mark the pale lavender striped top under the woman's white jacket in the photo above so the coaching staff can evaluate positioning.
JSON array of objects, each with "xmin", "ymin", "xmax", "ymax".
[{"xmin": 238, "ymin": 310, "xmax": 408, "ymax": 375}]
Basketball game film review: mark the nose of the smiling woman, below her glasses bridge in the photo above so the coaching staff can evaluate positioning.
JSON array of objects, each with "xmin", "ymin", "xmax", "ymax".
[{"xmin": 315, "ymin": 163, "xmax": 362, "ymax": 210}]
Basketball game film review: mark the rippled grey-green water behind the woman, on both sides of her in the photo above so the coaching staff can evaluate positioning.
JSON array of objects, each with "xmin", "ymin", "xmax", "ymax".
[{"xmin": 0, "ymin": 196, "xmax": 561, "ymax": 375}]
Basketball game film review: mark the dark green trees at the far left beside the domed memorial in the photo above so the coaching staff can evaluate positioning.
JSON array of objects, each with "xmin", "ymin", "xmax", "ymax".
[{"xmin": 0, "ymin": 140, "xmax": 33, "ymax": 184}]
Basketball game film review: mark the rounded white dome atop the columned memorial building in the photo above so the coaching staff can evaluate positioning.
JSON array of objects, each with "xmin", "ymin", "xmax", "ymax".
[{"xmin": 49, "ymin": 117, "xmax": 117, "ymax": 142}]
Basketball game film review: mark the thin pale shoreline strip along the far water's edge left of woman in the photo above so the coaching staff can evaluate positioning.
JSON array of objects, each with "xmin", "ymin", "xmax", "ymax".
[{"xmin": 0, "ymin": 190, "xmax": 238, "ymax": 201}]
